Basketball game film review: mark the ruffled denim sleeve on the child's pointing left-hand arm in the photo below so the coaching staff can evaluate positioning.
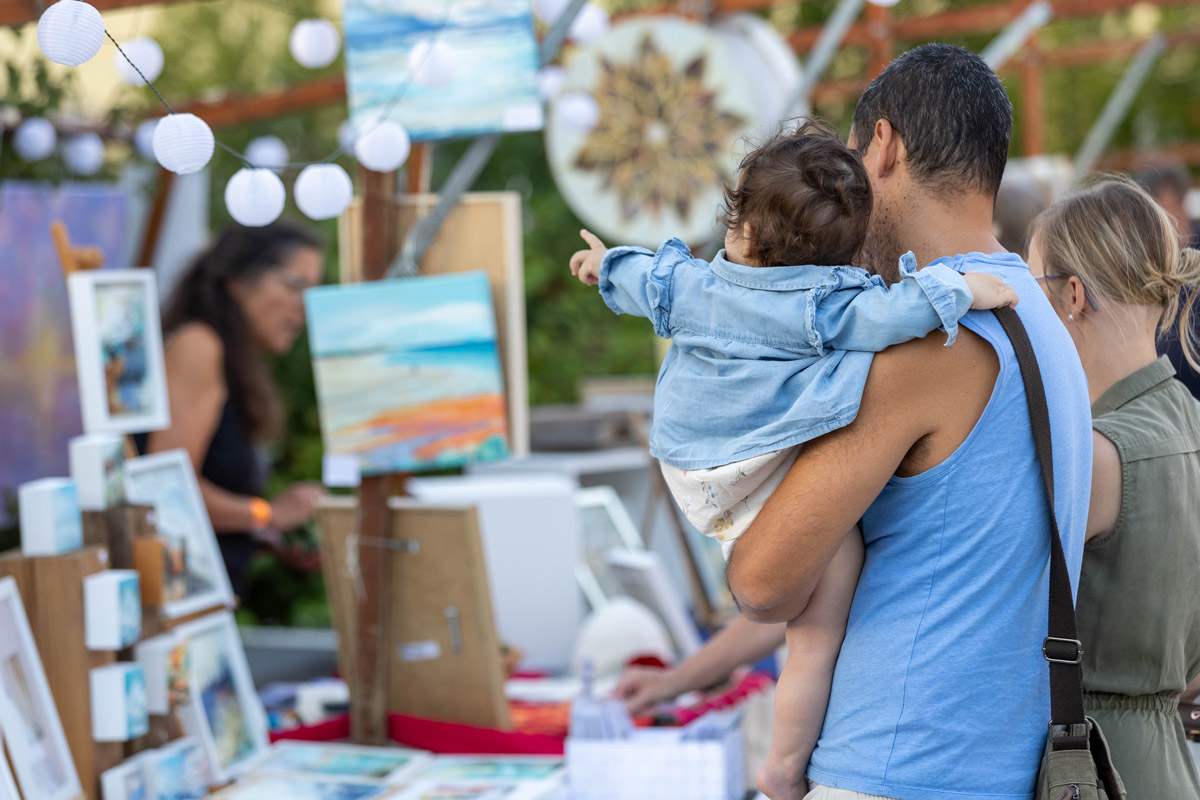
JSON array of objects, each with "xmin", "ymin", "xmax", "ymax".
[{"xmin": 600, "ymin": 239, "xmax": 691, "ymax": 338}]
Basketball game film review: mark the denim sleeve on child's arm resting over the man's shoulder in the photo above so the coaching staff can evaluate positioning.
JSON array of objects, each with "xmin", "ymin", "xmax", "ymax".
[{"xmin": 805, "ymin": 253, "xmax": 972, "ymax": 354}]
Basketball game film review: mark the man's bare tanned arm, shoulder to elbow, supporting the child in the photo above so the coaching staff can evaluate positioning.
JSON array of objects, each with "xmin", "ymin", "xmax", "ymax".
[{"xmin": 727, "ymin": 331, "xmax": 1000, "ymax": 622}]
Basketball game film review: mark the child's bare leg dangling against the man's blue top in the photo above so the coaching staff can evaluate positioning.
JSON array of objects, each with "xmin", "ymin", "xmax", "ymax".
[{"xmin": 757, "ymin": 528, "xmax": 863, "ymax": 800}]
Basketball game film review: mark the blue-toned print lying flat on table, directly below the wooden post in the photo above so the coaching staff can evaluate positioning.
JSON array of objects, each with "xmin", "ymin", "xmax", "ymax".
[{"xmin": 254, "ymin": 741, "xmax": 433, "ymax": 783}]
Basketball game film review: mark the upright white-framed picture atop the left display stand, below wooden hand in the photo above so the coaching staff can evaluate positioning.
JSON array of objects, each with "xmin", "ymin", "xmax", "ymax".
[{"xmin": 67, "ymin": 270, "xmax": 170, "ymax": 433}]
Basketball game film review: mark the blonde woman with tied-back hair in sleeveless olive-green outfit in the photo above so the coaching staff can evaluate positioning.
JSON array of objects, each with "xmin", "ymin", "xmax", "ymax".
[{"xmin": 1030, "ymin": 179, "xmax": 1200, "ymax": 800}]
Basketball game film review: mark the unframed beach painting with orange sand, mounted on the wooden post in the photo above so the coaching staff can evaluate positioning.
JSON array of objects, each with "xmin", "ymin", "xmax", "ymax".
[{"xmin": 305, "ymin": 272, "xmax": 509, "ymax": 475}]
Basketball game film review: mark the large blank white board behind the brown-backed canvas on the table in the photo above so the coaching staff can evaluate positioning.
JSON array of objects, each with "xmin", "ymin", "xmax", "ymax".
[{"xmin": 408, "ymin": 474, "xmax": 584, "ymax": 670}]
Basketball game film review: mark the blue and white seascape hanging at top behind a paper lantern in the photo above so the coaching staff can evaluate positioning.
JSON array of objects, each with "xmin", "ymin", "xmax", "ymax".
[{"xmin": 344, "ymin": 0, "xmax": 542, "ymax": 142}]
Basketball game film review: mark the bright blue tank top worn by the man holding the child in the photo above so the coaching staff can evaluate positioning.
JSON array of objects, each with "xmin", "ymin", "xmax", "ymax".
[{"xmin": 802, "ymin": 253, "xmax": 1092, "ymax": 800}]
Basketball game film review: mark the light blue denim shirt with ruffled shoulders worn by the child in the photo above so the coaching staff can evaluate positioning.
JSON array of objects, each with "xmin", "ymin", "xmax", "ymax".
[{"xmin": 600, "ymin": 239, "xmax": 972, "ymax": 469}]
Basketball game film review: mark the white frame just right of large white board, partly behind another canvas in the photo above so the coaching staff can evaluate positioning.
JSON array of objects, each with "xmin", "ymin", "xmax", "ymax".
[{"xmin": 575, "ymin": 486, "xmax": 642, "ymax": 609}]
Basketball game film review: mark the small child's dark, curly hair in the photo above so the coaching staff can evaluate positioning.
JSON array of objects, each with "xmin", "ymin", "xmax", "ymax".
[{"xmin": 721, "ymin": 120, "xmax": 871, "ymax": 266}]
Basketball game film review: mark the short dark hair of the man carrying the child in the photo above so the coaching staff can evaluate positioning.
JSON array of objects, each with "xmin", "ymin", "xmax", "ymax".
[{"xmin": 853, "ymin": 43, "xmax": 1013, "ymax": 196}]
